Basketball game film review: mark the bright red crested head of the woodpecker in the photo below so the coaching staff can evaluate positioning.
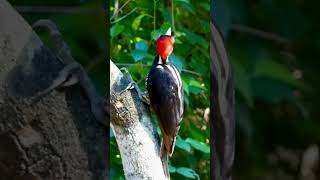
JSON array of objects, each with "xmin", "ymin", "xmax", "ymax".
[{"xmin": 157, "ymin": 35, "xmax": 174, "ymax": 63}]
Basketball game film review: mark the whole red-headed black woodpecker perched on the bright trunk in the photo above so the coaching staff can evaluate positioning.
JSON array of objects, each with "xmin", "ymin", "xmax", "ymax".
[{"xmin": 146, "ymin": 29, "xmax": 184, "ymax": 179}]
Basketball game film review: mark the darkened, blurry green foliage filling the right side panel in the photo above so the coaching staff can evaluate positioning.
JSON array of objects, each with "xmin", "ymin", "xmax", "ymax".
[{"xmin": 211, "ymin": 0, "xmax": 320, "ymax": 180}]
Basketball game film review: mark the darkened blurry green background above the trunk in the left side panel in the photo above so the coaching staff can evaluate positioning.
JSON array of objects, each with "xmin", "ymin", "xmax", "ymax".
[{"xmin": 9, "ymin": 0, "xmax": 109, "ymax": 95}]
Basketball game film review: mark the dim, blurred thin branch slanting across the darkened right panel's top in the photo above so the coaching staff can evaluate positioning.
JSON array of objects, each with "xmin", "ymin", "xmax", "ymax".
[{"xmin": 231, "ymin": 24, "xmax": 290, "ymax": 44}]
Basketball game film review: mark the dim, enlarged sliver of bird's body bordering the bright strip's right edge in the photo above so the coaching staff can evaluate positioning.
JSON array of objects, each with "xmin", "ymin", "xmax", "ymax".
[{"xmin": 210, "ymin": 0, "xmax": 235, "ymax": 180}]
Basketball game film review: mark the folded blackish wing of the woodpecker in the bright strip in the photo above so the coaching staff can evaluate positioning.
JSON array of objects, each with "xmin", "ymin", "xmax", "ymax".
[{"xmin": 147, "ymin": 65, "xmax": 183, "ymax": 154}]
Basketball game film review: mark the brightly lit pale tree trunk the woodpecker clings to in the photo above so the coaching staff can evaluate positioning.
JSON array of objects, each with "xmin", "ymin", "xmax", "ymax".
[{"xmin": 110, "ymin": 61, "xmax": 166, "ymax": 180}]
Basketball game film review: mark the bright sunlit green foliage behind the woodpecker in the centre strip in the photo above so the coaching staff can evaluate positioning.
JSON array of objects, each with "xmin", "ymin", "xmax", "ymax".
[{"xmin": 110, "ymin": 0, "xmax": 210, "ymax": 179}]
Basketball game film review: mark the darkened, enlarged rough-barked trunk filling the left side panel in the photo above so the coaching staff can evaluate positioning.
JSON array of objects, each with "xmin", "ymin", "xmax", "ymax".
[{"xmin": 0, "ymin": 0, "xmax": 108, "ymax": 179}]
